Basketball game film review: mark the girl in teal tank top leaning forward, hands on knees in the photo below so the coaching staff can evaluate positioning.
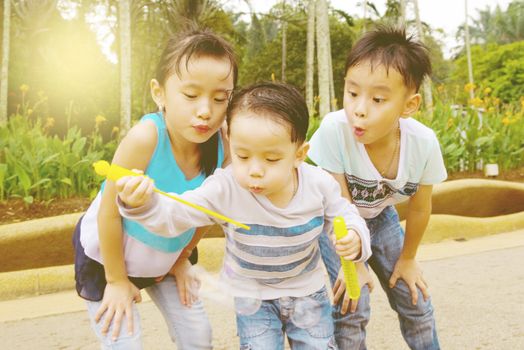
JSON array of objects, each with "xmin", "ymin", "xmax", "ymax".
[{"xmin": 73, "ymin": 31, "xmax": 238, "ymax": 350}]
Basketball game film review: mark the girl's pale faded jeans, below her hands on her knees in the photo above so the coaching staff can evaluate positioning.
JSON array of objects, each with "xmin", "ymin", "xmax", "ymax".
[{"xmin": 87, "ymin": 276, "xmax": 212, "ymax": 350}]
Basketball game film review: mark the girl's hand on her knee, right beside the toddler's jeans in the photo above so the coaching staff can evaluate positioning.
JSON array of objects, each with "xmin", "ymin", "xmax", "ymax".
[{"xmin": 168, "ymin": 258, "xmax": 201, "ymax": 307}]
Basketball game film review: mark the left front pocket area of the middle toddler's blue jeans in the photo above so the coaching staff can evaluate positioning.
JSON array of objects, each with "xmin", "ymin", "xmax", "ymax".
[{"xmin": 235, "ymin": 298, "xmax": 271, "ymax": 339}]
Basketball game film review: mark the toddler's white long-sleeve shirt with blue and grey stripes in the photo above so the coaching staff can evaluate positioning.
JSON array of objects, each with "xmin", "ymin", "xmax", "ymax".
[{"xmin": 119, "ymin": 163, "xmax": 371, "ymax": 300}]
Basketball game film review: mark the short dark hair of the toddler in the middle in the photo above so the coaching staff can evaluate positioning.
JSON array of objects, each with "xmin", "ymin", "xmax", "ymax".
[{"xmin": 227, "ymin": 82, "xmax": 309, "ymax": 143}]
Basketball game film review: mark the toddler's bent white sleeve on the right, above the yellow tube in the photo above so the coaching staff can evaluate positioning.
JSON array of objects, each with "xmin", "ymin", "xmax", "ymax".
[{"xmin": 324, "ymin": 173, "xmax": 371, "ymax": 262}]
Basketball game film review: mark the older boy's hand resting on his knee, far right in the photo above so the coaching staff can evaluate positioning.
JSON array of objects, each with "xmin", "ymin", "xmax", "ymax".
[{"xmin": 389, "ymin": 257, "xmax": 429, "ymax": 305}]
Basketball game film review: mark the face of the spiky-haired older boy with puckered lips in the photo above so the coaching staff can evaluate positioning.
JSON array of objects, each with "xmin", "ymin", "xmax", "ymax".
[{"xmin": 344, "ymin": 62, "xmax": 420, "ymax": 145}]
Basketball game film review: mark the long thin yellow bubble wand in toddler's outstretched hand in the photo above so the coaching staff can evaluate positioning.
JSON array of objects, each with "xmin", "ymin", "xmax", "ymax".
[{"xmin": 93, "ymin": 160, "xmax": 251, "ymax": 230}]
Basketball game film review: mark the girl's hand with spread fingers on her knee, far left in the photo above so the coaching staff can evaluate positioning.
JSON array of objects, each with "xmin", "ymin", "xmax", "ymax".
[{"xmin": 95, "ymin": 280, "xmax": 142, "ymax": 341}]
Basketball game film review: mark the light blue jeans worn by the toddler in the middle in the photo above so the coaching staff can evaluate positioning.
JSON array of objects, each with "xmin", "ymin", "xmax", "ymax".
[{"xmin": 235, "ymin": 287, "xmax": 338, "ymax": 350}]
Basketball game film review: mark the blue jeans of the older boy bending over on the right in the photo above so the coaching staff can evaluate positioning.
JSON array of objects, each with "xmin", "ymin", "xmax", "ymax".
[{"xmin": 319, "ymin": 207, "xmax": 440, "ymax": 350}]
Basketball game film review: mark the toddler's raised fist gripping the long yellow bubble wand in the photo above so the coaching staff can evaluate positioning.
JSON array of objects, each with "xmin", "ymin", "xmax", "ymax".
[{"xmin": 116, "ymin": 176, "xmax": 155, "ymax": 208}]
